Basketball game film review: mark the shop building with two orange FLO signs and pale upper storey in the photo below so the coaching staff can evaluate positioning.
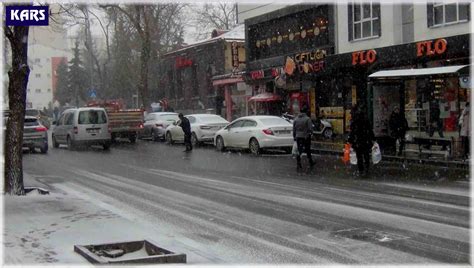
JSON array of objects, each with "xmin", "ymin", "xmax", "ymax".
[{"xmin": 245, "ymin": 1, "xmax": 471, "ymax": 138}]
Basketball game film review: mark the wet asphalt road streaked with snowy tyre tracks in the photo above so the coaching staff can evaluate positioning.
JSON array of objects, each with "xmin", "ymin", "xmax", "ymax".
[{"xmin": 24, "ymin": 135, "xmax": 471, "ymax": 264}]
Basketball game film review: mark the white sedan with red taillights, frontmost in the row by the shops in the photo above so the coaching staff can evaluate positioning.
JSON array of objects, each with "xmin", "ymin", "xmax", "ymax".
[{"xmin": 214, "ymin": 115, "xmax": 294, "ymax": 155}]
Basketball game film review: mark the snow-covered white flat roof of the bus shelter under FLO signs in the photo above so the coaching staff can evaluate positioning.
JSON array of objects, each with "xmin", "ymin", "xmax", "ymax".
[{"xmin": 369, "ymin": 65, "xmax": 469, "ymax": 78}]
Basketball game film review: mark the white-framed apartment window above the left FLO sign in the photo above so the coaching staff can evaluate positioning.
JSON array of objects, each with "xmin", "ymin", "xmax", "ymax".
[{"xmin": 348, "ymin": 1, "xmax": 381, "ymax": 41}]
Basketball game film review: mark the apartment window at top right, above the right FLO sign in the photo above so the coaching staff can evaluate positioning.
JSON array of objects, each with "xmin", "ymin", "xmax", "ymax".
[{"xmin": 427, "ymin": 1, "xmax": 470, "ymax": 27}]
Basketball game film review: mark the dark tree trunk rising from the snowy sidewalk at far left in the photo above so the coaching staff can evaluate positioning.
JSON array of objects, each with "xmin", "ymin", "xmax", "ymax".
[{"xmin": 4, "ymin": 26, "xmax": 30, "ymax": 195}]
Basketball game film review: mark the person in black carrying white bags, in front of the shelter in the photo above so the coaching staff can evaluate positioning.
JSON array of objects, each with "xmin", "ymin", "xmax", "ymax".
[{"xmin": 348, "ymin": 105, "xmax": 375, "ymax": 175}]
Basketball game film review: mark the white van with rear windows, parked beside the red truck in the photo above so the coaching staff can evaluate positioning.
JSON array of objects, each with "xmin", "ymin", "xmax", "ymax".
[{"xmin": 52, "ymin": 107, "xmax": 111, "ymax": 150}]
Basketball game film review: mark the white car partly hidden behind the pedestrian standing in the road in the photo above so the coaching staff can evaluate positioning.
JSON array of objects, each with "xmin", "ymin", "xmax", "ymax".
[{"xmin": 166, "ymin": 114, "xmax": 229, "ymax": 146}]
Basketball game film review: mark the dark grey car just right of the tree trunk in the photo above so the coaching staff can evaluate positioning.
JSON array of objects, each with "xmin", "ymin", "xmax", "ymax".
[{"xmin": 23, "ymin": 116, "xmax": 48, "ymax": 154}]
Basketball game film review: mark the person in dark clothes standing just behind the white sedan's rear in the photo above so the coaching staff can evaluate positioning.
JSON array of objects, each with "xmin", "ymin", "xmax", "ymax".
[{"xmin": 293, "ymin": 107, "xmax": 315, "ymax": 170}]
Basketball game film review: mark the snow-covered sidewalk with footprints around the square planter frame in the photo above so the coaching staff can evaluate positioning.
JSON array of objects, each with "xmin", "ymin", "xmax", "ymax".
[{"xmin": 3, "ymin": 174, "xmax": 216, "ymax": 265}]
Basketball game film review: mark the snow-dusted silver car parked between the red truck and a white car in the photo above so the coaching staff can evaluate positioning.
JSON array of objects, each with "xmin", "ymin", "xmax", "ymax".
[{"xmin": 141, "ymin": 112, "xmax": 179, "ymax": 141}]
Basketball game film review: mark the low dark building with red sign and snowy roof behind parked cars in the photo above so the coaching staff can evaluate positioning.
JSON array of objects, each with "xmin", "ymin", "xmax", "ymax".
[{"xmin": 156, "ymin": 25, "xmax": 248, "ymax": 119}]
